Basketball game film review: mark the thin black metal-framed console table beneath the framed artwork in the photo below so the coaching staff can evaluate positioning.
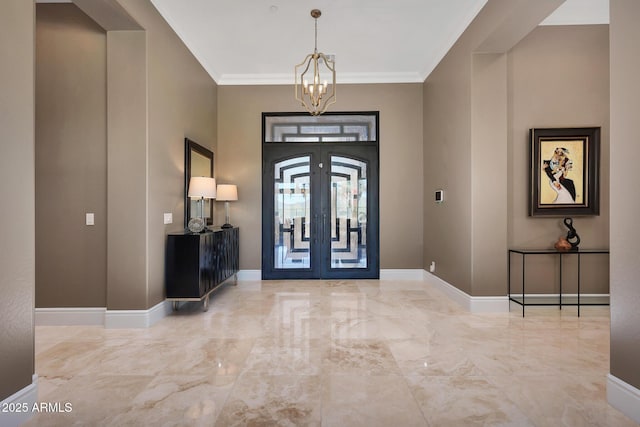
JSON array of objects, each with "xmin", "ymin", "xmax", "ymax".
[{"xmin": 507, "ymin": 249, "xmax": 609, "ymax": 317}]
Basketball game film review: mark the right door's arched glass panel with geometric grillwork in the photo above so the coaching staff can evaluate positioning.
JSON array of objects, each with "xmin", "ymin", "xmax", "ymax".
[{"xmin": 330, "ymin": 156, "xmax": 367, "ymax": 268}]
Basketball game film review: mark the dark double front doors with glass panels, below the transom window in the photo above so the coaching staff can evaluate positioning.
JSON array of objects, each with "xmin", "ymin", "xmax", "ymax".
[{"xmin": 262, "ymin": 142, "xmax": 379, "ymax": 279}]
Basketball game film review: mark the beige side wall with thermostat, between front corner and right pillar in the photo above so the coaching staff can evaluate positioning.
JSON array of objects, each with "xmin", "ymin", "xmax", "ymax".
[{"xmin": 423, "ymin": 51, "xmax": 471, "ymax": 294}]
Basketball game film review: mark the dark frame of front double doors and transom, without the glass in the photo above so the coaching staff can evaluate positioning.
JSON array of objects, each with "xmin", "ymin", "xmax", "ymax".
[{"xmin": 262, "ymin": 113, "xmax": 380, "ymax": 280}]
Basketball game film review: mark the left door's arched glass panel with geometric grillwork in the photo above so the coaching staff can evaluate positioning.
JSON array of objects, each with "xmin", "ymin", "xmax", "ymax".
[{"xmin": 273, "ymin": 156, "xmax": 313, "ymax": 269}]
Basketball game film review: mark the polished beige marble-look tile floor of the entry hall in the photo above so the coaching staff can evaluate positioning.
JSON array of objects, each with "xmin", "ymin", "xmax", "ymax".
[{"xmin": 27, "ymin": 280, "xmax": 637, "ymax": 427}]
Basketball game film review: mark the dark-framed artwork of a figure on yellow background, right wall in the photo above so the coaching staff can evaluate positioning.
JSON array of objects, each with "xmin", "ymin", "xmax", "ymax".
[{"xmin": 529, "ymin": 127, "xmax": 600, "ymax": 216}]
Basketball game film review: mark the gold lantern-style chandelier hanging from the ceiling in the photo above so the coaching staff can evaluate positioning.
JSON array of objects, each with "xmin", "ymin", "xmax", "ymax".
[{"xmin": 294, "ymin": 9, "xmax": 336, "ymax": 116}]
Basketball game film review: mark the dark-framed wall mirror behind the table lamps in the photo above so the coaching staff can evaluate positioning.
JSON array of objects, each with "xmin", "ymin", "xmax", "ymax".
[{"xmin": 184, "ymin": 138, "xmax": 213, "ymax": 228}]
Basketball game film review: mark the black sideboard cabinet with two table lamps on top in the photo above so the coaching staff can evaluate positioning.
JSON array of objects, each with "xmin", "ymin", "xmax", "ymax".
[{"xmin": 165, "ymin": 227, "xmax": 239, "ymax": 311}]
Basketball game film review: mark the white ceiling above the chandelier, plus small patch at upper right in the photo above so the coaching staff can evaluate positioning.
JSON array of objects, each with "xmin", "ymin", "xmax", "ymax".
[{"xmin": 151, "ymin": 0, "xmax": 609, "ymax": 85}]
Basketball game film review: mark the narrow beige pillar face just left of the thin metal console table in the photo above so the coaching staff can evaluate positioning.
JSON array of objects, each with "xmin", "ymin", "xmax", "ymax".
[{"xmin": 470, "ymin": 53, "xmax": 508, "ymax": 295}]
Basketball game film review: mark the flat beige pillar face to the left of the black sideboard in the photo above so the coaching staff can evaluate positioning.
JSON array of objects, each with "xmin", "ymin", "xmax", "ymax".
[{"xmin": 105, "ymin": 31, "xmax": 149, "ymax": 310}]
